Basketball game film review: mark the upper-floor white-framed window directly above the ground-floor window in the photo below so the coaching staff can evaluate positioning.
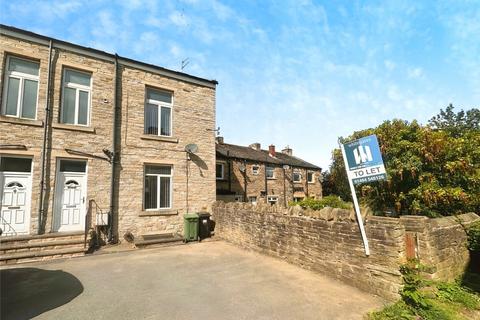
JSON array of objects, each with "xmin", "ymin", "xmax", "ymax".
[{"xmin": 144, "ymin": 88, "xmax": 173, "ymax": 137}]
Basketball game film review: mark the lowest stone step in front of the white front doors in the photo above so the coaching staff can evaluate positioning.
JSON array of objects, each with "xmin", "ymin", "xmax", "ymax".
[{"xmin": 0, "ymin": 246, "xmax": 85, "ymax": 265}]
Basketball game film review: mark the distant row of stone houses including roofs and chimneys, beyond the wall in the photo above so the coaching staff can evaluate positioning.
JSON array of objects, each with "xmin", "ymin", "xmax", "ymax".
[{"xmin": 216, "ymin": 137, "xmax": 322, "ymax": 206}]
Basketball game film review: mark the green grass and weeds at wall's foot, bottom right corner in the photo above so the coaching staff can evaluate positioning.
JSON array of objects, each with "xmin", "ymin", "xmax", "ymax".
[{"xmin": 368, "ymin": 261, "xmax": 480, "ymax": 320}]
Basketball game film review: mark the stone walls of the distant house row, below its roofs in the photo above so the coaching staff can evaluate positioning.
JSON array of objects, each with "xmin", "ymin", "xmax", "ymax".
[{"xmin": 216, "ymin": 141, "xmax": 322, "ymax": 206}]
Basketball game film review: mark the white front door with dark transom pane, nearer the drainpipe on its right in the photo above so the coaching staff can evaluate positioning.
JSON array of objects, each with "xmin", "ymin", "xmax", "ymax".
[{"xmin": 53, "ymin": 160, "xmax": 87, "ymax": 232}]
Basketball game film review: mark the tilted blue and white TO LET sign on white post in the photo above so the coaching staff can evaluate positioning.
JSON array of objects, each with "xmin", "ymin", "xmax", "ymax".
[{"xmin": 340, "ymin": 135, "xmax": 387, "ymax": 256}]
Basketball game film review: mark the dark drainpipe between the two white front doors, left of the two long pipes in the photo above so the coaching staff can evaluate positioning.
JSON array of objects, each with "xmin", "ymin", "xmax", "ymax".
[{"xmin": 38, "ymin": 40, "xmax": 53, "ymax": 234}]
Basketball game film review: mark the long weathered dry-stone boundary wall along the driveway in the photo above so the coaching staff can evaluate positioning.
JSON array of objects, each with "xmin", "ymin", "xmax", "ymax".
[{"xmin": 213, "ymin": 202, "xmax": 479, "ymax": 299}]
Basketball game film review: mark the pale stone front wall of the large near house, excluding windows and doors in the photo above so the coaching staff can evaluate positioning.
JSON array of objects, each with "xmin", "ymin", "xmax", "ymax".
[{"xmin": 0, "ymin": 26, "xmax": 216, "ymax": 240}]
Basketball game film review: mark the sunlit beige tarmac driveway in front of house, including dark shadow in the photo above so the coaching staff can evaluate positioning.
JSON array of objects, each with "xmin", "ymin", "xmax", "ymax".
[{"xmin": 0, "ymin": 241, "xmax": 382, "ymax": 319}]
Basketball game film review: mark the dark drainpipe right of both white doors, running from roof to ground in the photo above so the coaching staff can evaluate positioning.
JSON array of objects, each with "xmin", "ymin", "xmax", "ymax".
[{"xmin": 108, "ymin": 53, "xmax": 119, "ymax": 243}]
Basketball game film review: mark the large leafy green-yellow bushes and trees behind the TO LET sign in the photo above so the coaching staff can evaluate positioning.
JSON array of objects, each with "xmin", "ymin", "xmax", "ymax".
[{"xmin": 324, "ymin": 105, "xmax": 480, "ymax": 217}]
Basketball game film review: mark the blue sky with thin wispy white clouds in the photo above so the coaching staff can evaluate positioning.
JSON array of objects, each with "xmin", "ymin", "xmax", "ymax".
[{"xmin": 0, "ymin": 0, "xmax": 480, "ymax": 169}]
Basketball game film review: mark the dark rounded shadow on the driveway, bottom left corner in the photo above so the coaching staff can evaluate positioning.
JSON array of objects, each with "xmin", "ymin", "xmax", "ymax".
[{"xmin": 0, "ymin": 268, "xmax": 83, "ymax": 320}]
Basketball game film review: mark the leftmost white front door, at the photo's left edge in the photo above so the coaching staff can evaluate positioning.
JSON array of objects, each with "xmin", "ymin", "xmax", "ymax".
[{"xmin": 0, "ymin": 172, "xmax": 32, "ymax": 236}]
